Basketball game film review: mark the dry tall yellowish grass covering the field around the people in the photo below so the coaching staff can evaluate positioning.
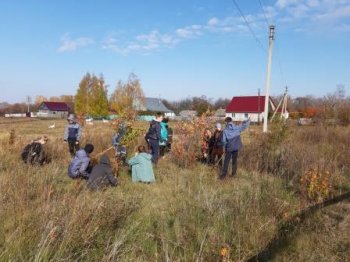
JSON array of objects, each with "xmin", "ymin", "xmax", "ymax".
[{"xmin": 0, "ymin": 120, "xmax": 349, "ymax": 261}]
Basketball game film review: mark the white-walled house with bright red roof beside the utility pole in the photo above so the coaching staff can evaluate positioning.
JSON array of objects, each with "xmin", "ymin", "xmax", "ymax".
[{"xmin": 226, "ymin": 96, "xmax": 288, "ymax": 122}]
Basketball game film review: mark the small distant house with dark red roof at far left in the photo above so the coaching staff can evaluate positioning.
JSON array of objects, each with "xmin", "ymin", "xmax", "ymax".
[{"xmin": 37, "ymin": 101, "xmax": 70, "ymax": 118}]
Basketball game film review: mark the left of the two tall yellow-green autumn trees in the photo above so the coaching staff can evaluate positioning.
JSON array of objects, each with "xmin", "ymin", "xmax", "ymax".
[{"xmin": 75, "ymin": 73, "xmax": 108, "ymax": 117}]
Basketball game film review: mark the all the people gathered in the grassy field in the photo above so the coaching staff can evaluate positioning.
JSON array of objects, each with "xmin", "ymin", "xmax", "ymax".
[{"xmin": 21, "ymin": 113, "xmax": 250, "ymax": 189}]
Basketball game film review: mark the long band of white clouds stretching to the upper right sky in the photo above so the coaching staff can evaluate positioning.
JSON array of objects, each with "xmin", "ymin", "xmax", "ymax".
[{"xmin": 98, "ymin": 0, "xmax": 350, "ymax": 55}]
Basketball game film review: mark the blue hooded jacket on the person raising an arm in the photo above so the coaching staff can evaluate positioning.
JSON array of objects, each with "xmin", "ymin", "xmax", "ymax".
[{"xmin": 222, "ymin": 119, "xmax": 250, "ymax": 152}]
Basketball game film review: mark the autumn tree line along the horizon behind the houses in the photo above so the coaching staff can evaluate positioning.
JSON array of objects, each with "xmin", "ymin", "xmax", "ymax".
[{"xmin": 0, "ymin": 73, "xmax": 350, "ymax": 124}]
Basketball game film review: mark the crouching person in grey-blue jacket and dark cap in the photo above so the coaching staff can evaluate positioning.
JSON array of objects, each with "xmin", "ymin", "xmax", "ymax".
[{"xmin": 68, "ymin": 144, "xmax": 94, "ymax": 180}]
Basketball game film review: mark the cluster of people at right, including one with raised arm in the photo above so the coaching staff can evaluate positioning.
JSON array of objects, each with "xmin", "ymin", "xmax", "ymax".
[{"xmin": 201, "ymin": 117, "xmax": 250, "ymax": 180}]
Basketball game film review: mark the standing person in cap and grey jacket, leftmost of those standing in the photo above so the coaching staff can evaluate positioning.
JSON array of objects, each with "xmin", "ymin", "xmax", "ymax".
[{"xmin": 63, "ymin": 114, "xmax": 81, "ymax": 157}]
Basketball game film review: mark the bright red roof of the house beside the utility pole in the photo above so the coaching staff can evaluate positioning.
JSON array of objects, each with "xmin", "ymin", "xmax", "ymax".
[{"xmin": 226, "ymin": 96, "xmax": 273, "ymax": 113}]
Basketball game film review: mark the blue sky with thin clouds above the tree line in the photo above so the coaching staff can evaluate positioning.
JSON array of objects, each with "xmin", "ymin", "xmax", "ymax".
[{"xmin": 0, "ymin": 0, "xmax": 350, "ymax": 103}]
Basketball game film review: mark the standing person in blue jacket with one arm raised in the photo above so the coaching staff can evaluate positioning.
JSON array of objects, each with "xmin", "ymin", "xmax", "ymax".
[{"xmin": 219, "ymin": 117, "xmax": 250, "ymax": 179}]
